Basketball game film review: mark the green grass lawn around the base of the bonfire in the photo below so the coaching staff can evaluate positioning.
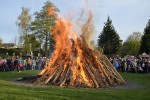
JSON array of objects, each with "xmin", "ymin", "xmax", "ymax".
[{"xmin": 0, "ymin": 71, "xmax": 150, "ymax": 100}]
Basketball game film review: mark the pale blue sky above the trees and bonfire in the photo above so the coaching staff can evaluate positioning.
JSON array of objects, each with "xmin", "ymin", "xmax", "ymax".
[{"xmin": 0, "ymin": 0, "xmax": 150, "ymax": 43}]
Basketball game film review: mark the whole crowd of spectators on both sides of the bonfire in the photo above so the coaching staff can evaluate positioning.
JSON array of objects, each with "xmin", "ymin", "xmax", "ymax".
[{"xmin": 0, "ymin": 56, "xmax": 150, "ymax": 74}]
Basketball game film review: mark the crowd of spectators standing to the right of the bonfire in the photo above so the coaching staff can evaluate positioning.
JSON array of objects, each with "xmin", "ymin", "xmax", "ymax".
[{"xmin": 110, "ymin": 57, "xmax": 150, "ymax": 74}]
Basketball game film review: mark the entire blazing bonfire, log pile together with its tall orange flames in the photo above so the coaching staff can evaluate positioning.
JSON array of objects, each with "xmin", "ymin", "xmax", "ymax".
[{"xmin": 34, "ymin": 4, "xmax": 125, "ymax": 88}]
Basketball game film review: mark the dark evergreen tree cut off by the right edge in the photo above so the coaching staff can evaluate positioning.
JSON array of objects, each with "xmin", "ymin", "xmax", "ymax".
[{"xmin": 140, "ymin": 19, "xmax": 150, "ymax": 54}]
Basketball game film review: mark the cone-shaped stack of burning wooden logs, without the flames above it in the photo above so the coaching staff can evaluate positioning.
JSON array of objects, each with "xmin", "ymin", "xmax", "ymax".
[{"xmin": 32, "ymin": 36, "xmax": 125, "ymax": 88}]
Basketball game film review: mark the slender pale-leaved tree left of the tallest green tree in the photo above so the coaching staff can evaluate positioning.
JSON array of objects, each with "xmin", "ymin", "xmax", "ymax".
[{"xmin": 17, "ymin": 7, "xmax": 31, "ymax": 53}]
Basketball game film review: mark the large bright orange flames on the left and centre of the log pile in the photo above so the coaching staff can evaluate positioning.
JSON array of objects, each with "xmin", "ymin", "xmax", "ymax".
[{"xmin": 40, "ymin": 18, "xmax": 90, "ymax": 86}]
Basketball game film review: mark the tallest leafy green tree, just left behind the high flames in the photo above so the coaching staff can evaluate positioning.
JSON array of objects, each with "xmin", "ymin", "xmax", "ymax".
[{"xmin": 31, "ymin": 1, "xmax": 59, "ymax": 57}]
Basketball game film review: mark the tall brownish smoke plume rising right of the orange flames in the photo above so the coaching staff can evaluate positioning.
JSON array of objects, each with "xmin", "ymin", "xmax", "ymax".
[{"xmin": 77, "ymin": 0, "xmax": 94, "ymax": 49}]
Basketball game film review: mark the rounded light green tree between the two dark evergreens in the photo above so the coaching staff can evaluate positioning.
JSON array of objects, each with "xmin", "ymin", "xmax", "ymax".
[{"xmin": 121, "ymin": 32, "xmax": 142, "ymax": 56}]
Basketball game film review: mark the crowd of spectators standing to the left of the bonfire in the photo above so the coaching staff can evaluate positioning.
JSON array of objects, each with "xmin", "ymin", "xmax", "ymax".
[{"xmin": 0, "ymin": 56, "xmax": 46, "ymax": 72}]
